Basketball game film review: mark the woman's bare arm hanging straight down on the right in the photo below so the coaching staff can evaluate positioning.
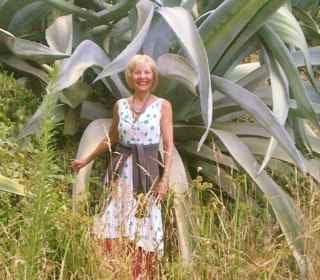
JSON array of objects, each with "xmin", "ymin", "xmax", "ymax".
[{"xmin": 156, "ymin": 100, "xmax": 174, "ymax": 200}]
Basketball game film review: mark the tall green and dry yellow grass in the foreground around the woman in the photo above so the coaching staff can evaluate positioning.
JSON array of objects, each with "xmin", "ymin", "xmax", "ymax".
[{"xmin": 0, "ymin": 71, "xmax": 320, "ymax": 280}]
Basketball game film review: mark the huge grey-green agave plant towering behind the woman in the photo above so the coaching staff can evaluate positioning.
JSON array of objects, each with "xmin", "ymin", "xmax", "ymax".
[{"xmin": 1, "ymin": 0, "xmax": 320, "ymax": 277}]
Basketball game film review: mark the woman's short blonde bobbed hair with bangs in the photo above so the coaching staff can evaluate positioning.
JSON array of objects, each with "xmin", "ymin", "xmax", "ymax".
[{"xmin": 125, "ymin": 54, "xmax": 159, "ymax": 92}]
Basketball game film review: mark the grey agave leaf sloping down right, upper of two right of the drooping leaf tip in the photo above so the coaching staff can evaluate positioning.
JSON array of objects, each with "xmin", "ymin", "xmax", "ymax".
[{"xmin": 213, "ymin": 76, "xmax": 304, "ymax": 171}]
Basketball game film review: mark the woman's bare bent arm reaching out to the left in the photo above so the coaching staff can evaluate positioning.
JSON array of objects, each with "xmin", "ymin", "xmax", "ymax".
[{"xmin": 71, "ymin": 102, "xmax": 119, "ymax": 173}]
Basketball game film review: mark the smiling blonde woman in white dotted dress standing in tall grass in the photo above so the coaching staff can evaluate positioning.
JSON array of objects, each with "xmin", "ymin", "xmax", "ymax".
[{"xmin": 72, "ymin": 55, "xmax": 173, "ymax": 279}]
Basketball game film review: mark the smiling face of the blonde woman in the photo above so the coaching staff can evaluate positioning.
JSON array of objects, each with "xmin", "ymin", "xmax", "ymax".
[{"xmin": 131, "ymin": 63, "xmax": 154, "ymax": 93}]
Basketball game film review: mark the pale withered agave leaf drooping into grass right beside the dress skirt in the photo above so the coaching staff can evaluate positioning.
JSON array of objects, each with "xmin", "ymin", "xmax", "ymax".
[{"xmin": 170, "ymin": 145, "xmax": 191, "ymax": 266}]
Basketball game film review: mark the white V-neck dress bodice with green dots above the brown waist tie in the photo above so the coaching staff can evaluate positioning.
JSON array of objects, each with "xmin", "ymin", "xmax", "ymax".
[{"xmin": 118, "ymin": 98, "xmax": 162, "ymax": 145}]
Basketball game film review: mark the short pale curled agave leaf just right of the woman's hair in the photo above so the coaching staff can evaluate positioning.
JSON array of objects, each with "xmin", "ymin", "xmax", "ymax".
[{"xmin": 157, "ymin": 53, "xmax": 199, "ymax": 95}]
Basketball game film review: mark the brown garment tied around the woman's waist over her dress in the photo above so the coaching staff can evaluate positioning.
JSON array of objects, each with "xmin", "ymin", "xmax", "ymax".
[{"xmin": 106, "ymin": 143, "xmax": 162, "ymax": 194}]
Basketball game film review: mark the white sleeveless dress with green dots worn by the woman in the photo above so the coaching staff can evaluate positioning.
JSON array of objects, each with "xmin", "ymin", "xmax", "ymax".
[{"xmin": 94, "ymin": 98, "xmax": 163, "ymax": 254}]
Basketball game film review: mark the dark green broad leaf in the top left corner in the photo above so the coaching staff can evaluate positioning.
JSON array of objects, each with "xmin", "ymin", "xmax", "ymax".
[{"xmin": 8, "ymin": 1, "xmax": 51, "ymax": 35}]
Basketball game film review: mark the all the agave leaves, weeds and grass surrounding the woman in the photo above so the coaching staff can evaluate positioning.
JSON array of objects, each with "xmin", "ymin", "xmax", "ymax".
[{"xmin": 0, "ymin": 0, "xmax": 320, "ymax": 279}]
